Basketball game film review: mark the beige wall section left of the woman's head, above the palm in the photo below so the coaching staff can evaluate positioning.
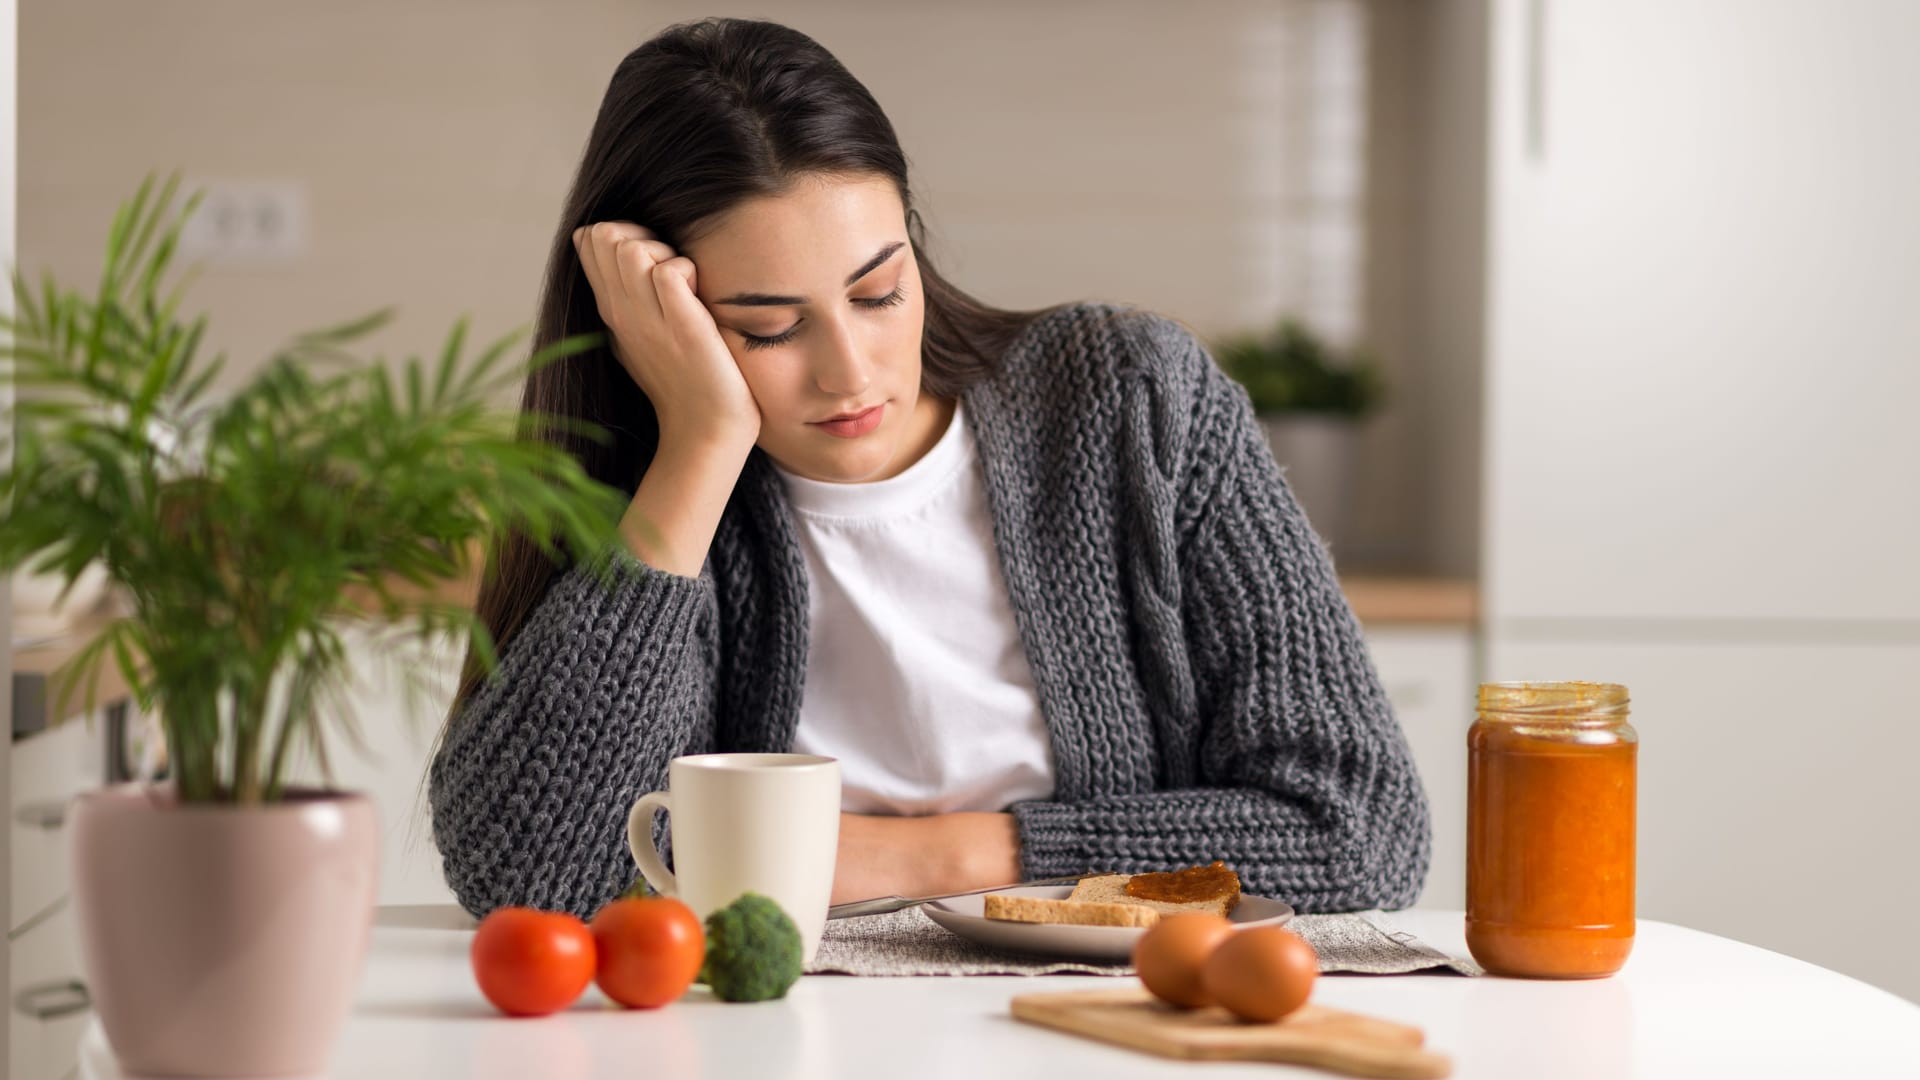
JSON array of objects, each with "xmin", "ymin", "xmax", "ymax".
[{"xmin": 19, "ymin": 0, "xmax": 641, "ymax": 397}]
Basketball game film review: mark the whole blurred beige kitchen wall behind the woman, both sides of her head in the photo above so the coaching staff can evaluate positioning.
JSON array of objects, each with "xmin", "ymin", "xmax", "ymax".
[{"xmin": 19, "ymin": 0, "xmax": 1473, "ymax": 567}]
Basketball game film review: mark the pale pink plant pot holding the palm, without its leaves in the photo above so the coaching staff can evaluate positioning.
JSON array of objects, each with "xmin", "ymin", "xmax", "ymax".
[{"xmin": 71, "ymin": 784, "xmax": 380, "ymax": 1076}]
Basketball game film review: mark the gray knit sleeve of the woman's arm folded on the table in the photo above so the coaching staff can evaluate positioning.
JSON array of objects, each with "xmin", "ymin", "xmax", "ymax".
[{"xmin": 1012, "ymin": 320, "xmax": 1430, "ymax": 911}]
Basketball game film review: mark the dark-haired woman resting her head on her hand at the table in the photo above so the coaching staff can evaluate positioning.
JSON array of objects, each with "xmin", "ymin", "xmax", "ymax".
[{"xmin": 430, "ymin": 19, "xmax": 1428, "ymax": 915}]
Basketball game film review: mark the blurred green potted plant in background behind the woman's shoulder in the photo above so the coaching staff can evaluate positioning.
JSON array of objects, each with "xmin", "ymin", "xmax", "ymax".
[{"xmin": 1213, "ymin": 319, "xmax": 1386, "ymax": 553}]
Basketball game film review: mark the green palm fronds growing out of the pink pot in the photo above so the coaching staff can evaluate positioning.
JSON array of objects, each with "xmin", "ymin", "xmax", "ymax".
[{"xmin": 0, "ymin": 177, "xmax": 626, "ymax": 801}]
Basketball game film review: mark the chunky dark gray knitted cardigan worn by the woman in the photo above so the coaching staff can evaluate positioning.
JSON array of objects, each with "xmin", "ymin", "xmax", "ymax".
[{"xmin": 430, "ymin": 304, "xmax": 1428, "ymax": 917}]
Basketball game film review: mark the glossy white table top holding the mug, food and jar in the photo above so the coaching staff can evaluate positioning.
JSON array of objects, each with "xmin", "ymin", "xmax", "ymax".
[{"xmin": 81, "ymin": 905, "xmax": 1920, "ymax": 1080}]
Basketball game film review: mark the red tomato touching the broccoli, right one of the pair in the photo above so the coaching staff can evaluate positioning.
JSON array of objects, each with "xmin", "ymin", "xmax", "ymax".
[{"xmin": 593, "ymin": 896, "xmax": 707, "ymax": 1009}]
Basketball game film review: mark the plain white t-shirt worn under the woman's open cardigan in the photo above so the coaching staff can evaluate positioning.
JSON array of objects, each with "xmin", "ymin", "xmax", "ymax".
[{"xmin": 780, "ymin": 404, "xmax": 1054, "ymax": 815}]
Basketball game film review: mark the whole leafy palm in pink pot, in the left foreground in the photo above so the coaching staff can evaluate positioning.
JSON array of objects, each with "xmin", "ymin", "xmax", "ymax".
[{"xmin": 0, "ymin": 177, "xmax": 624, "ymax": 1076}]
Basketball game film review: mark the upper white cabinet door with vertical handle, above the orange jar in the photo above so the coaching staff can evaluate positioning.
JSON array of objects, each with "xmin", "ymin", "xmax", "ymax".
[{"xmin": 1482, "ymin": 0, "xmax": 1920, "ymax": 625}]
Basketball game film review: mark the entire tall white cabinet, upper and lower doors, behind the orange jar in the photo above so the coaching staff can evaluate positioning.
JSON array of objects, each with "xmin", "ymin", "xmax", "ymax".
[{"xmin": 1482, "ymin": 0, "xmax": 1920, "ymax": 999}]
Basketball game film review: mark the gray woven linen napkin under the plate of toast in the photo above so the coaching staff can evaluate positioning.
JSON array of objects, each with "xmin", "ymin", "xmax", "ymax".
[{"xmin": 806, "ymin": 907, "xmax": 1482, "ymax": 974}]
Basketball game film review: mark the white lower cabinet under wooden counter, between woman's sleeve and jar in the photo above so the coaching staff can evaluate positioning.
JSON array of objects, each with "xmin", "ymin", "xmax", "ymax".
[{"xmin": 1365, "ymin": 623, "xmax": 1478, "ymax": 907}]
